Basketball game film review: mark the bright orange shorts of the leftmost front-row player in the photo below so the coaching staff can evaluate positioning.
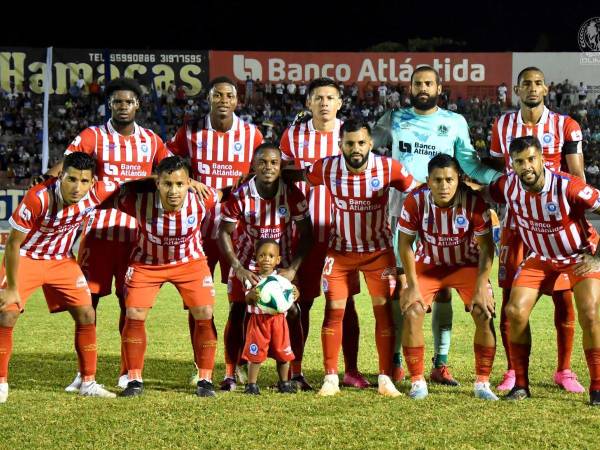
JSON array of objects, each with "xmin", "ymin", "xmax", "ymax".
[{"xmin": 0, "ymin": 256, "xmax": 92, "ymax": 313}]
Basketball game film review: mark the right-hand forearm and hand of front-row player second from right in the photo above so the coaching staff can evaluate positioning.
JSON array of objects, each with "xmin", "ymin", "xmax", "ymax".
[{"xmin": 468, "ymin": 232, "xmax": 496, "ymax": 319}]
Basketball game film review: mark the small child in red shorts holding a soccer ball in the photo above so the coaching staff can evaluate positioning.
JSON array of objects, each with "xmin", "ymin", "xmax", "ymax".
[{"xmin": 242, "ymin": 239, "xmax": 298, "ymax": 395}]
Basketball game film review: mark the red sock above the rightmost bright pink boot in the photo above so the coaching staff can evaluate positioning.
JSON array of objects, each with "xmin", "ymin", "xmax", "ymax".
[{"xmin": 552, "ymin": 290, "xmax": 575, "ymax": 372}]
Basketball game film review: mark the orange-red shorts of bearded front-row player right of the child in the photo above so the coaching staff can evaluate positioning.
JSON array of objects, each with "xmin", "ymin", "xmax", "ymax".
[{"xmin": 323, "ymin": 248, "xmax": 396, "ymax": 301}]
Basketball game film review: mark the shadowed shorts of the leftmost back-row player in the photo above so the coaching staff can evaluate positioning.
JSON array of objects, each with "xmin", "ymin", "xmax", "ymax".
[{"xmin": 77, "ymin": 231, "xmax": 135, "ymax": 297}]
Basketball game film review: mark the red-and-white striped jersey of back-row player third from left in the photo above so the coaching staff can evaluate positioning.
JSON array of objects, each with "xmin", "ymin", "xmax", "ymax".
[{"xmin": 279, "ymin": 119, "xmax": 342, "ymax": 243}]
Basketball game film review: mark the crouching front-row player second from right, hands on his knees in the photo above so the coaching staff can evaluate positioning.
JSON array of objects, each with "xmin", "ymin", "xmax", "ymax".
[{"xmin": 398, "ymin": 154, "xmax": 498, "ymax": 400}]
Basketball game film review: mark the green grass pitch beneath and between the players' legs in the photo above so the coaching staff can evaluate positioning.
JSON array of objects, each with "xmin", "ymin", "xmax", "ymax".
[{"xmin": 0, "ymin": 260, "xmax": 600, "ymax": 449}]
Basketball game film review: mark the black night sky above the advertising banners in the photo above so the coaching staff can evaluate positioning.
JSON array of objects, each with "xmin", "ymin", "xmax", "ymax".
[{"xmin": 0, "ymin": 0, "xmax": 600, "ymax": 51}]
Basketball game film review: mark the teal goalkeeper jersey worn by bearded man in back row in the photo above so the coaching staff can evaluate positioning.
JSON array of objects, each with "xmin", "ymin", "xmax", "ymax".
[{"xmin": 373, "ymin": 108, "xmax": 502, "ymax": 217}]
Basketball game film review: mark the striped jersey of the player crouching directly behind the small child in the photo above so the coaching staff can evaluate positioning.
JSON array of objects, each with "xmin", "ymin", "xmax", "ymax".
[{"xmin": 221, "ymin": 178, "xmax": 310, "ymax": 270}]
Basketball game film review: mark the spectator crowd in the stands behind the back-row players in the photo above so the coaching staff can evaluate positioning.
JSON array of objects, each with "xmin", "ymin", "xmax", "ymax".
[{"xmin": 0, "ymin": 79, "xmax": 600, "ymax": 188}]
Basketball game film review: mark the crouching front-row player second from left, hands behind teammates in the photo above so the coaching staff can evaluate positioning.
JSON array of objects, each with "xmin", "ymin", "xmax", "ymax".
[{"xmin": 115, "ymin": 156, "xmax": 220, "ymax": 397}]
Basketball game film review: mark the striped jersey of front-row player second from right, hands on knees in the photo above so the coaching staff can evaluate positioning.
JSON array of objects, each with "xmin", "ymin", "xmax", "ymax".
[{"xmin": 398, "ymin": 184, "xmax": 491, "ymax": 266}]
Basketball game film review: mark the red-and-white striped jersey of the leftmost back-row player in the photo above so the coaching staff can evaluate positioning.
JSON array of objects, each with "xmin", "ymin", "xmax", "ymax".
[{"xmin": 65, "ymin": 120, "xmax": 170, "ymax": 242}]
